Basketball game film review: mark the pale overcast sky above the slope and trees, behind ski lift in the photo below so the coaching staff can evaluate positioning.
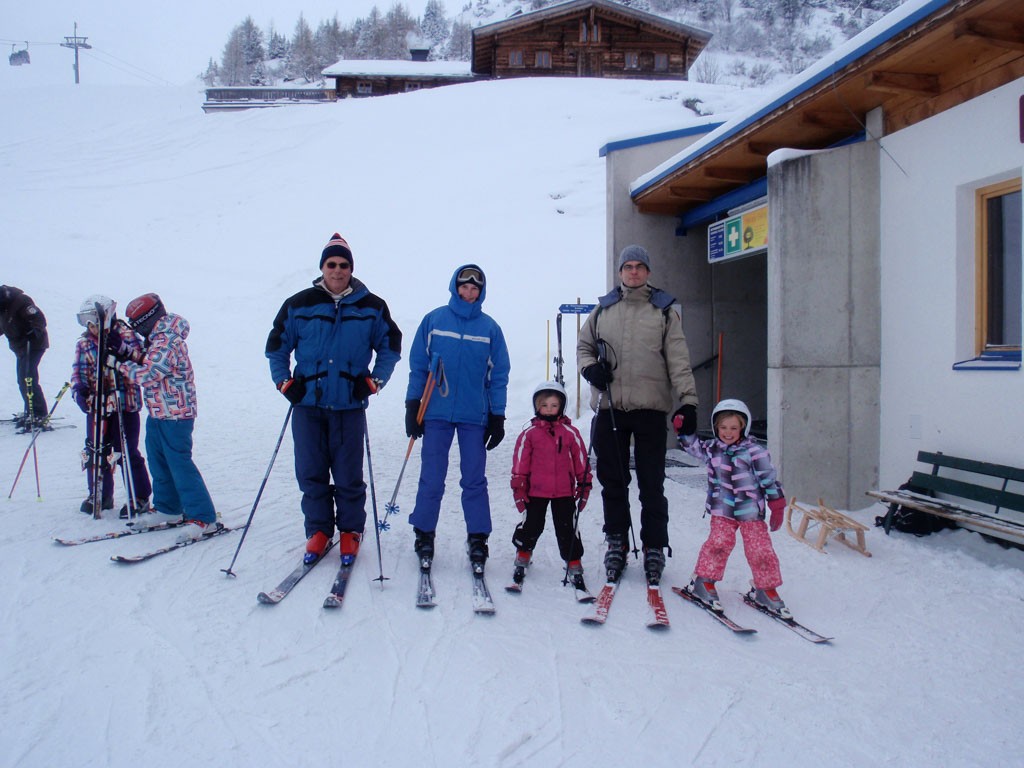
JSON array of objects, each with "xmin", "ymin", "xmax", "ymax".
[{"xmin": 0, "ymin": 0, "xmax": 432, "ymax": 86}]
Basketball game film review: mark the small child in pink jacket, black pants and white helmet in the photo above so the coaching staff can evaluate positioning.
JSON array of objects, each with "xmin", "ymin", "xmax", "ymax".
[{"xmin": 511, "ymin": 381, "xmax": 591, "ymax": 592}]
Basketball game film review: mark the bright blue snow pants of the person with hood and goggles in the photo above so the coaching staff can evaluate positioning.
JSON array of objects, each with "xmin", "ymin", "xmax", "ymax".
[{"xmin": 409, "ymin": 420, "xmax": 490, "ymax": 536}]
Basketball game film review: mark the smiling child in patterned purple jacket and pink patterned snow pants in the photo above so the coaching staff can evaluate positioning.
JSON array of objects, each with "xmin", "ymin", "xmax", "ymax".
[{"xmin": 679, "ymin": 399, "xmax": 791, "ymax": 617}]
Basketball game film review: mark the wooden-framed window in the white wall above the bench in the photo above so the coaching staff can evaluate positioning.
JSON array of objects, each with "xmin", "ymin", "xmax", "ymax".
[{"xmin": 975, "ymin": 178, "xmax": 1024, "ymax": 360}]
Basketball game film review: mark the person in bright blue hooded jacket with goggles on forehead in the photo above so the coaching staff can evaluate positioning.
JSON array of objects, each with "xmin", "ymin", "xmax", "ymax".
[{"xmin": 406, "ymin": 264, "xmax": 511, "ymax": 571}]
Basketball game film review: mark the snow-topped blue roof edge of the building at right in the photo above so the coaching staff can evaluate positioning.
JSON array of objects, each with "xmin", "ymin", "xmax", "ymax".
[{"xmin": 630, "ymin": 0, "xmax": 956, "ymax": 197}]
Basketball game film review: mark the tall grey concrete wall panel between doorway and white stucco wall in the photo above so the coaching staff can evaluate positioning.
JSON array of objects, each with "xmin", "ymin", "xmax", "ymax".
[{"xmin": 768, "ymin": 142, "xmax": 881, "ymax": 509}]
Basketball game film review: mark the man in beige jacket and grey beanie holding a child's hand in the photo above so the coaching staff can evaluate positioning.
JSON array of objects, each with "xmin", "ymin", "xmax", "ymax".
[{"xmin": 577, "ymin": 245, "xmax": 697, "ymax": 586}]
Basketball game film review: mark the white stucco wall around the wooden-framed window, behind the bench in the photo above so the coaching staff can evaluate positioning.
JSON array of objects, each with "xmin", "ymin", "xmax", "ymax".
[{"xmin": 879, "ymin": 78, "xmax": 1024, "ymax": 488}]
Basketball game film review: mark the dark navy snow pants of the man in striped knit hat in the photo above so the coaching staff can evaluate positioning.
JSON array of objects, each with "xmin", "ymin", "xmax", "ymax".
[{"xmin": 292, "ymin": 406, "xmax": 367, "ymax": 539}]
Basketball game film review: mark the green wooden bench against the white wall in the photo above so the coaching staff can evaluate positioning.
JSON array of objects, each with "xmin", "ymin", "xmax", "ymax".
[{"xmin": 867, "ymin": 451, "xmax": 1024, "ymax": 545}]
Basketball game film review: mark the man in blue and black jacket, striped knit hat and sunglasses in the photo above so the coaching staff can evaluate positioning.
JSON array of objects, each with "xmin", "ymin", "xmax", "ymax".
[{"xmin": 266, "ymin": 232, "xmax": 401, "ymax": 563}]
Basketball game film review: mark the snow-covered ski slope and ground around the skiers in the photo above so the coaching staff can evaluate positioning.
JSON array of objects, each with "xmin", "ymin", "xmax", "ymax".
[{"xmin": 0, "ymin": 80, "xmax": 1024, "ymax": 768}]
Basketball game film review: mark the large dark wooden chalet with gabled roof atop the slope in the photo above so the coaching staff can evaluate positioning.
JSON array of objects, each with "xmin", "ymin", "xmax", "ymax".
[{"xmin": 471, "ymin": 0, "xmax": 711, "ymax": 80}]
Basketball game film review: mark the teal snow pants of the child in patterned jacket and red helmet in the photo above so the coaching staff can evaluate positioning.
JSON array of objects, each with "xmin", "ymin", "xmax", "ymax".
[{"xmin": 145, "ymin": 416, "xmax": 217, "ymax": 523}]
